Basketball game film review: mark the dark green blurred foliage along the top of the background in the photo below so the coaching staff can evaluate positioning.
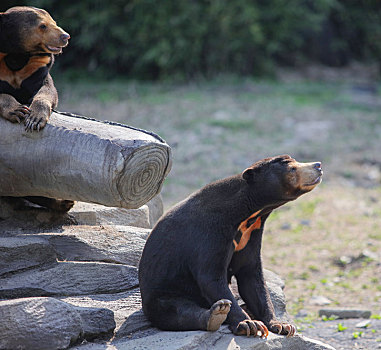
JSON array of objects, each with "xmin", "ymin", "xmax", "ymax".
[{"xmin": 0, "ymin": 0, "xmax": 381, "ymax": 79}]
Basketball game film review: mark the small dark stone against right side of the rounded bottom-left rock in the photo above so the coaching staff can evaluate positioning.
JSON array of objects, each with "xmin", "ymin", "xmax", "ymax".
[{"xmin": 75, "ymin": 307, "xmax": 115, "ymax": 340}]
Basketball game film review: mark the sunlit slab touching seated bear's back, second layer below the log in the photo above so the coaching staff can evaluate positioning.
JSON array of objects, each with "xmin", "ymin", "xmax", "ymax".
[{"xmin": 46, "ymin": 225, "xmax": 150, "ymax": 266}]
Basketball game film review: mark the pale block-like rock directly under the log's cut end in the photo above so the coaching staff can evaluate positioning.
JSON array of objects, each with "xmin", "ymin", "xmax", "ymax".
[{"xmin": 70, "ymin": 202, "xmax": 151, "ymax": 228}]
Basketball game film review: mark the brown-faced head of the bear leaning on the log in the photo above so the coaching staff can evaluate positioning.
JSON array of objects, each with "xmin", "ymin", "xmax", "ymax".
[{"xmin": 0, "ymin": 6, "xmax": 70, "ymax": 55}]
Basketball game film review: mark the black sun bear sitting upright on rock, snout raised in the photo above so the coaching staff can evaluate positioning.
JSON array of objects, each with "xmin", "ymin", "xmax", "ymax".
[{"xmin": 139, "ymin": 155, "xmax": 323, "ymax": 337}]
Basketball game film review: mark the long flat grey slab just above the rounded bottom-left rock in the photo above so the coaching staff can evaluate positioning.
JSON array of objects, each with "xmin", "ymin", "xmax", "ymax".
[{"xmin": 0, "ymin": 262, "xmax": 138, "ymax": 298}]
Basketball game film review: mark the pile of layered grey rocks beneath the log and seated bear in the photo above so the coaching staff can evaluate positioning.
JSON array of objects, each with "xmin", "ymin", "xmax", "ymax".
[{"xmin": 0, "ymin": 197, "xmax": 333, "ymax": 350}]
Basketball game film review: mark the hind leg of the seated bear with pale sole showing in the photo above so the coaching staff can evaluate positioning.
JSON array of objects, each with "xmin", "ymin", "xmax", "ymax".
[{"xmin": 148, "ymin": 298, "xmax": 231, "ymax": 331}]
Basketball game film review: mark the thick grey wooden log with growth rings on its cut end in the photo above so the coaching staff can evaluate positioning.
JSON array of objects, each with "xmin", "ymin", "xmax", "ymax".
[{"xmin": 0, "ymin": 112, "xmax": 171, "ymax": 208}]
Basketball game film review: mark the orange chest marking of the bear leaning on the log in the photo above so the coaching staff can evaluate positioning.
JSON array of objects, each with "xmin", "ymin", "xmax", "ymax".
[{"xmin": 0, "ymin": 53, "xmax": 50, "ymax": 89}]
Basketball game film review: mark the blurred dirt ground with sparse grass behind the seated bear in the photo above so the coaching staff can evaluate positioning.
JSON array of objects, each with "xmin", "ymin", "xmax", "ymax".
[{"xmin": 57, "ymin": 67, "xmax": 381, "ymax": 349}]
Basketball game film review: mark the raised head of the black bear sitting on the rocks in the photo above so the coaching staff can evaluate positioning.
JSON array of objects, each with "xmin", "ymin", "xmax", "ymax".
[{"xmin": 242, "ymin": 155, "xmax": 323, "ymax": 203}]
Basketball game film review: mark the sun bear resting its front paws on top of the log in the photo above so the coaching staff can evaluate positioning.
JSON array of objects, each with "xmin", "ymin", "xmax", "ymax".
[{"xmin": 0, "ymin": 6, "xmax": 70, "ymax": 131}]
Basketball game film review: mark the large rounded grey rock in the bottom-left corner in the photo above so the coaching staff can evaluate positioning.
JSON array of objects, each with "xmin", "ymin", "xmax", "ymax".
[{"xmin": 0, "ymin": 298, "xmax": 82, "ymax": 350}]
